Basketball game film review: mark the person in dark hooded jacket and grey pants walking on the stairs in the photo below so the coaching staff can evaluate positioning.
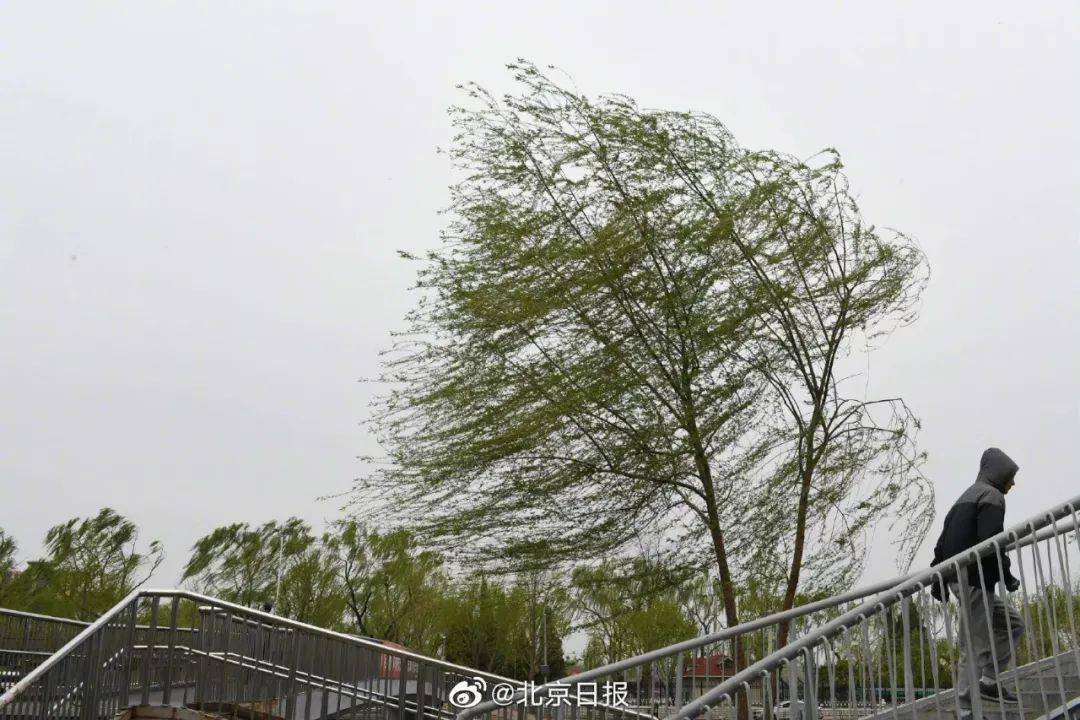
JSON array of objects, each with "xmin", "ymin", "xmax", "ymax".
[{"xmin": 931, "ymin": 448, "xmax": 1024, "ymax": 709}]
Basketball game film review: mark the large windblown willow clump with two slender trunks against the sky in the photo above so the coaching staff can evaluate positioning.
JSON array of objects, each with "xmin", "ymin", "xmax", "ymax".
[{"xmin": 354, "ymin": 64, "xmax": 931, "ymax": 660}]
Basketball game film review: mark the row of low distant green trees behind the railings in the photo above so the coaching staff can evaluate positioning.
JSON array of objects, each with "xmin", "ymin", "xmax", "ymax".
[{"xmin": 0, "ymin": 507, "xmax": 721, "ymax": 680}]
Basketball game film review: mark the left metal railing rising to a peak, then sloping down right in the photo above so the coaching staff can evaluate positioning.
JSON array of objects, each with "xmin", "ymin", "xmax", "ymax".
[{"xmin": 0, "ymin": 589, "xmax": 639, "ymax": 720}]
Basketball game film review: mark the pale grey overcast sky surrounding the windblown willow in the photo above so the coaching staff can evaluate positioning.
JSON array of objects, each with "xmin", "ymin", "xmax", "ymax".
[{"xmin": 0, "ymin": 0, "xmax": 1080, "ymax": 585}]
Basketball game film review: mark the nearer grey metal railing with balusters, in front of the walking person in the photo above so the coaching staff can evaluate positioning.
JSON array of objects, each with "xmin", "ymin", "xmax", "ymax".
[{"xmin": 669, "ymin": 497, "xmax": 1080, "ymax": 720}]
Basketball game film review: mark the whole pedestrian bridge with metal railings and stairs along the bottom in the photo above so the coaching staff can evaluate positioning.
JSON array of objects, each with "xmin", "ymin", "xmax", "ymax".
[{"xmin": 0, "ymin": 497, "xmax": 1080, "ymax": 720}]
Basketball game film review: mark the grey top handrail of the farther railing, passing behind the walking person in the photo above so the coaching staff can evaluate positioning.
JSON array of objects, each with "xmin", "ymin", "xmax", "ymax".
[{"xmin": 458, "ymin": 515, "xmax": 1071, "ymax": 720}]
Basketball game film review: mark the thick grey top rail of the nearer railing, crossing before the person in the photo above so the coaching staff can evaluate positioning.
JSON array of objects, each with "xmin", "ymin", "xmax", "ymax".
[{"xmin": 666, "ymin": 495, "xmax": 1080, "ymax": 720}]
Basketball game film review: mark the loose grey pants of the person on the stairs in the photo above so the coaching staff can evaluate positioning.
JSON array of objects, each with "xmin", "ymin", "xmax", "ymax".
[{"xmin": 948, "ymin": 583, "xmax": 1024, "ymax": 706}]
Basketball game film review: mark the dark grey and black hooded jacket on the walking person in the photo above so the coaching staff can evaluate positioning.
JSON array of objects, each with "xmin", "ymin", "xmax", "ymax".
[{"xmin": 933, "ymin": 448, "xmax": 1020, "ymax": 596}]
